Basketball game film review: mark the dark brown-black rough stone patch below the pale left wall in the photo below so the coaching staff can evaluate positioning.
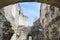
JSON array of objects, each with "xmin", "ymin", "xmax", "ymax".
[{"xmin": 2, "ymin": 20, "xmax": 14, "ymax": 40}]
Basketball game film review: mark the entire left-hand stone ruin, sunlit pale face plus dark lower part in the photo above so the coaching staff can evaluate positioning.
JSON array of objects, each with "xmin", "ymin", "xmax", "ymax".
[{"xmin": 0, "ymin": 3, "xmax": 29, "ymax": 40}]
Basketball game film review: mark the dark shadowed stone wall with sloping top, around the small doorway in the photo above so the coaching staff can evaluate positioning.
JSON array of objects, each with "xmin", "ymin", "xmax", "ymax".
[{"xmin": 27, "ymin": 18, "xmax": 44, "ymax": 40}]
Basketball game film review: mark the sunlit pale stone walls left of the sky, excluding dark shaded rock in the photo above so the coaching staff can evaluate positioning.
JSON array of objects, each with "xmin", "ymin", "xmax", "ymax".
[{"xmin": 2, "ymin": 3, "xmax": 29, "ymax": 40}]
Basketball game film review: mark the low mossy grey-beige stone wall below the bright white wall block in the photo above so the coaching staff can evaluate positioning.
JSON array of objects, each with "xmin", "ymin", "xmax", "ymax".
[{"xmin": 18, "ymin": 26, "xmax": 30, "ymax": 40}]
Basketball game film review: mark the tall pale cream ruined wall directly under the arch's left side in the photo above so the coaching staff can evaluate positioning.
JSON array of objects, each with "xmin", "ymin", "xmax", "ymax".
[{"xmin": 3, "ymin": 3, "xmax": 20, "ymax": 30}]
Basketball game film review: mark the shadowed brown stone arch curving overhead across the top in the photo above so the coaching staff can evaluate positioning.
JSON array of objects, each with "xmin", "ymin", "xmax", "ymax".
[{"xmin": 0, "ymin": 0, "xmax": 60, "ymax": 8}]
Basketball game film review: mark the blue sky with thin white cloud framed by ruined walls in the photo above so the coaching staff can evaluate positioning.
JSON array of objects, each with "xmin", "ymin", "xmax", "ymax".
[{"xmin": 19, "ymin": 2, "xmax": 40, "ymax": 26}]
